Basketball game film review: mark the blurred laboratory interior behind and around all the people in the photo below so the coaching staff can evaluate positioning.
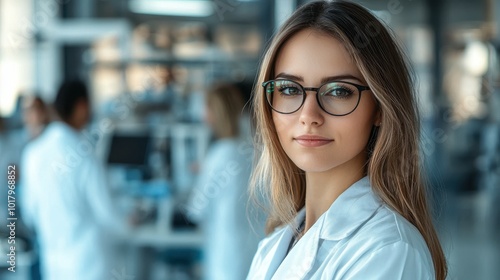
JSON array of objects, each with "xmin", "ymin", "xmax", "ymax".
[{"xmin": 0, "ymin": 0, "xmax": 500, "ymax": 280}]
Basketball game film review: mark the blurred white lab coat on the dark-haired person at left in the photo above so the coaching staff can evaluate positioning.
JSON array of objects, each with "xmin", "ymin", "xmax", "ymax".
[{"xmin": 19, "ymin": 122, "xmax": 125, "ymax": 280}]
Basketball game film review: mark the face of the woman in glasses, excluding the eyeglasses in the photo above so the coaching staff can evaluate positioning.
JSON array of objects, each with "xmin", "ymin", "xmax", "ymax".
[{"xmin": 272, "ymin": 29, "xmax": 379, "ymax": 172}]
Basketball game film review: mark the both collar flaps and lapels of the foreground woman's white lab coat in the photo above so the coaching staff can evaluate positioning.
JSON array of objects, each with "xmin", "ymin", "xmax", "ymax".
[{"xmin": 266, "ymin": 177, "xmax": 381, "ymax": 279}]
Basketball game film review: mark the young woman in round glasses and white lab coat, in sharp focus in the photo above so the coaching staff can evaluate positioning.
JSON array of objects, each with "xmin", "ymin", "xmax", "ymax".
[{"xmin": 247, "ymin": 1, "xmax": 447, "ymax": 280}]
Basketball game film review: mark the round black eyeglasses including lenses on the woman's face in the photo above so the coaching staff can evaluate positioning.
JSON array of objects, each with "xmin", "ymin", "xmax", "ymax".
[{"xmin": 262, "ymin": 79, "xmax": 370, "ymax": 116}]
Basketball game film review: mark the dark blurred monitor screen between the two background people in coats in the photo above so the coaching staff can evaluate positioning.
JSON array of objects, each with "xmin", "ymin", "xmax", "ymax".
[{"xmin": 108, "ymin": 134, "xmax": 151, "ymax": 167}]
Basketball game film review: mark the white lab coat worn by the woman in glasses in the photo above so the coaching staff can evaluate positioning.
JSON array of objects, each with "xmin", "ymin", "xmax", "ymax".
[{"xmin": 247, "ymin": 177, "xmax": 434, "ymax": 280}]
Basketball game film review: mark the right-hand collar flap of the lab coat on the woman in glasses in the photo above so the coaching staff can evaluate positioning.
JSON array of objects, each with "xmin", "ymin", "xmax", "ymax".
[{"xmin": 319, "ymin": 176, "xmax": 382, "ymax": 241}]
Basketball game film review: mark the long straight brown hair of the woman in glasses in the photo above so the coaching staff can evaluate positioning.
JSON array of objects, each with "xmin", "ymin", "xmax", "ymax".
[{"xmin": 251, "ymin": 1, "xmax": 447, "ymax": 279}]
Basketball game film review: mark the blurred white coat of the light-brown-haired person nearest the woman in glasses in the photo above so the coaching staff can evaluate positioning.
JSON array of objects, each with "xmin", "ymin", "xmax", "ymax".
[{"xmin": 188, "ymin": 139, "xmax": 265, "ymax": 280}]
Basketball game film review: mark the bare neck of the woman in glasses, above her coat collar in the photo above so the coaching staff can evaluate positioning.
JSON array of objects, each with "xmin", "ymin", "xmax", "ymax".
[{"xmin": 305, "ymin": 154, "xmax": 366, "ymax": 232}]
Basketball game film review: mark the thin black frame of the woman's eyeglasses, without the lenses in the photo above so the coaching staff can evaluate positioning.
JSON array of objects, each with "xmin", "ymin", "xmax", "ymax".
[{"xmin": 262, "ymin": 79, "xmax": 370, "ymax": 117}]
